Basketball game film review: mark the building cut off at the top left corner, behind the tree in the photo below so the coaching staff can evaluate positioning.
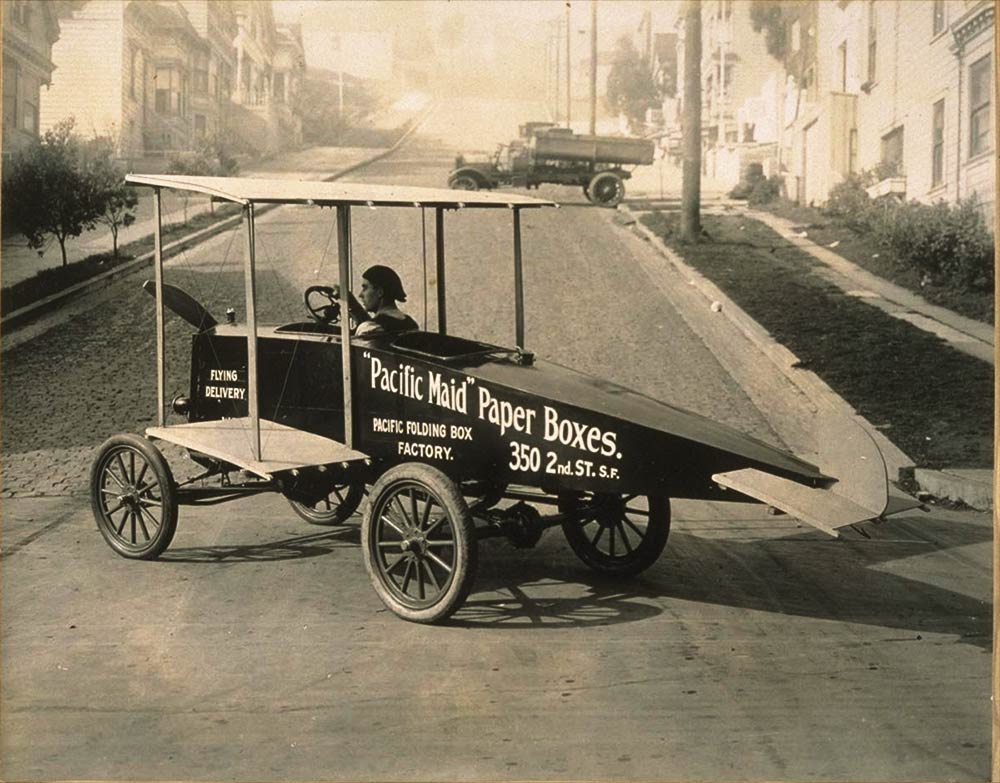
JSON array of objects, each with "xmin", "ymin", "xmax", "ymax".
[{"xmin": 3, "ymin": 0, "xmax": 60, "ymax": 160}]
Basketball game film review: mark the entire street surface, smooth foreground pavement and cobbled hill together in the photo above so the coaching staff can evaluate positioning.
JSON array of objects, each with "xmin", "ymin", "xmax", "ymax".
[{"xmin": 0, "ymin": 101, "xmax": 991, "ymax": 780}]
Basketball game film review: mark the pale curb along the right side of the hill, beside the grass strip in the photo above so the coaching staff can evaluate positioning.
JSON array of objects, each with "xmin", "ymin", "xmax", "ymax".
[{"xmin": 620, "ymin": 205, "xmax": 915, "ymax": 481}]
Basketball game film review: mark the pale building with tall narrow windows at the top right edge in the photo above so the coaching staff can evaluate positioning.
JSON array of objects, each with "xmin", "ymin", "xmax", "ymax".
[{"xmin": 845, "ymin": 0, "xmax": 996, "ymax": 215}]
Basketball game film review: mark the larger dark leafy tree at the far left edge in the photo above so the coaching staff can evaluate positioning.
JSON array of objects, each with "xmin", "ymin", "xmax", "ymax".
[{"xmin": 3, "ymin": 117, "xmax": 103, "ymax": 266}]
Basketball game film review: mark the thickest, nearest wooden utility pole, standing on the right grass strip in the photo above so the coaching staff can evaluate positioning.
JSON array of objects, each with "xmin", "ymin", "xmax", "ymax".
[{"xmin": 681, "ymin": 0, "xmax": 701, "ymax": 242}]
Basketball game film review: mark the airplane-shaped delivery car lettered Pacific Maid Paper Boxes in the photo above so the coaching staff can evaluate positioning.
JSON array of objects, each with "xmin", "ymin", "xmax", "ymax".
[{"xmin": 90, "ymin": 175, "xmax": 912, "ymax": 622}]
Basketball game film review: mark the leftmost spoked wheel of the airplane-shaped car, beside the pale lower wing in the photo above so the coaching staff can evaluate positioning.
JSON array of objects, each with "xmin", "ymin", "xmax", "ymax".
[{"xmin": 90, "ymin": 435, "xmax": 177, "ymax": 560}]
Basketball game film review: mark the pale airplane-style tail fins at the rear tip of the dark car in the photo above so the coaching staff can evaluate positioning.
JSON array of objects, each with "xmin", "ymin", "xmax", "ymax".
[{"xmin": 712, "ymin": 417, "xmax": 920, "ymax": 537}]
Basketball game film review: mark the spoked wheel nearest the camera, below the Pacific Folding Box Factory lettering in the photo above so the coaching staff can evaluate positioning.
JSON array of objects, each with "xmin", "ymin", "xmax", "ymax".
[{"xmin": 361, "ymin": 462, "xmax": 478, "ymax": 623}]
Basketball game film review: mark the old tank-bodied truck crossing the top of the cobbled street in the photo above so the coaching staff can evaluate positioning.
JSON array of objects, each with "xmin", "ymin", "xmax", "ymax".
[{"xmin": 448, "ymin": 122, "xmax": 654, "ymax": 207}]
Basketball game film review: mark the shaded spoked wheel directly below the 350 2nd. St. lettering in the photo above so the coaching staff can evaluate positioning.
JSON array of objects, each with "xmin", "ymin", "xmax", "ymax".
[{"xmin": 559, "ymin": 494, "xmax": 670, "ymax": 576}]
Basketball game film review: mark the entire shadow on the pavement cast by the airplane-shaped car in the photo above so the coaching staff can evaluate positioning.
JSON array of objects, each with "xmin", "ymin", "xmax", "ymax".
[{"xmin": 146, "ymin": 506, "xmax": 992, "ymax": 651}]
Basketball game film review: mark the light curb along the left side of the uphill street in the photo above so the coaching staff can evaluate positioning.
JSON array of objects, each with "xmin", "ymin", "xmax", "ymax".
[{"xmin": 0, "ymin": 103, "xmax": 436, "ymax": 340}]
